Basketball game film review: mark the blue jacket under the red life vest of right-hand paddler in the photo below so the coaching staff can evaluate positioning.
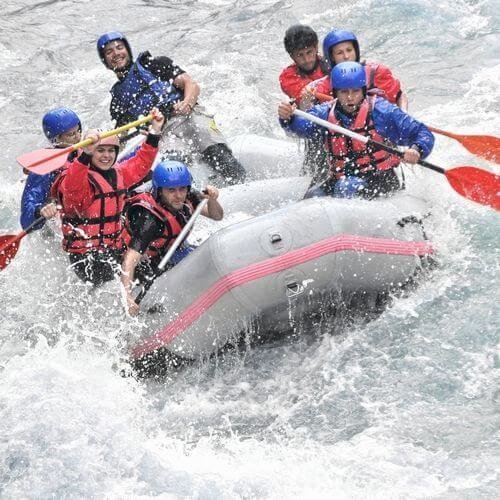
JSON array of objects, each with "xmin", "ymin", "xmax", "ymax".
[{"xmin": 280, "ymin": 98, "xmax": 434, "ymax": 159}]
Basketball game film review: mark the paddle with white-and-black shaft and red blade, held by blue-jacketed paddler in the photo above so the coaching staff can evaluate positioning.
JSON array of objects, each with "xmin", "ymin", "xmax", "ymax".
[{"xmin": 293, "ymin": 109, "xmax": 500, "ymax": 210}]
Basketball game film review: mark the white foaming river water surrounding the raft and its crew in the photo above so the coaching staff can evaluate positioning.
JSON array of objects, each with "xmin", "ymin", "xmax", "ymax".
[{"xmin": 0, "ymin": 0, "xmax": 500, "ymax": 499}]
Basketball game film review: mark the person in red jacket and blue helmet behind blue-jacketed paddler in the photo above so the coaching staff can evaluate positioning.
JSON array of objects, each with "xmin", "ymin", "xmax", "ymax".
[{"xmin": 306, "ymin": 29, "xmax": 408, "ymax": 111}]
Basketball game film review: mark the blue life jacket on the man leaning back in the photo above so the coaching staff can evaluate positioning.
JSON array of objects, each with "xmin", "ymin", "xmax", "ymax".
[{"xmin": 111, "ymin": 53, "xmax": 182, "ymax": 120}]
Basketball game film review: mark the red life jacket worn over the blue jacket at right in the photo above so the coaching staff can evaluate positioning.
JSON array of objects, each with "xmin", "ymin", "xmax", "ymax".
[{"xmin": 325, "ymin": 97, "xmax": 400, "ymax": 178}]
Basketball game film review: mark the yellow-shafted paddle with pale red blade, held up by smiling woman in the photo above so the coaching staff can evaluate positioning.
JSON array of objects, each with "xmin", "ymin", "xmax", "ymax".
[{"xmin": 16, "ymin": 115, "xmax": 153, "ymax": 175}]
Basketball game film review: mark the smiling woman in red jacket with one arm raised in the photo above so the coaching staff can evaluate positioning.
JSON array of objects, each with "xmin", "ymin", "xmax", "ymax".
[{"xmin": 52, "ymin": 109, "xmax": 164, "ymax": 286}]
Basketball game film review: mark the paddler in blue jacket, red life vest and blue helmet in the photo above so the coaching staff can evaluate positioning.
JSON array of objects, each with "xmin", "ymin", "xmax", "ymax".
[{"xmin": 278, "ymin": 62, "xmax": 434, "ymax": 198}]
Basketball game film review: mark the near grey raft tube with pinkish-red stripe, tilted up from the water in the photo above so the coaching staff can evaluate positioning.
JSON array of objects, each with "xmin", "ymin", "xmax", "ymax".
[{"xmin": 132, "ymin": 193, "xmax": 433, "ymax": 370}]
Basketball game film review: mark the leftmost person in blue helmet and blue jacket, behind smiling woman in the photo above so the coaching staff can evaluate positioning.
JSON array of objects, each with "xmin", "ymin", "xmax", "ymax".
[{"xmin": 20, "ymin": 107, "xmax": 82, "ymax": 229}]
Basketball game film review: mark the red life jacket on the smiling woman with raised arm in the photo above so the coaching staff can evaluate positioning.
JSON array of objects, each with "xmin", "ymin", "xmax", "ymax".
[{"xmin": 52, "ymin": 168, "xmax": 127, "ymax": 254}]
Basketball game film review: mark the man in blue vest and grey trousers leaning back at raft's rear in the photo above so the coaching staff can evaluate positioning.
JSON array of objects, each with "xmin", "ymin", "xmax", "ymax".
[{"xmin": 97, "ymin": 31, "xmax": 246, "ymax": 188}]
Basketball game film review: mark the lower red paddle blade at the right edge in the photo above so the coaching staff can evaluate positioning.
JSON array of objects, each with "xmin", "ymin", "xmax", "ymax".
[{"xmin": 445, "ymin": 167, "xmax": 500, "ymax": 210}]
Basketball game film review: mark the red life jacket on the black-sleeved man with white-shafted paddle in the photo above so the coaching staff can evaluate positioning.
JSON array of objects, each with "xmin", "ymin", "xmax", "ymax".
[{"xmin": 126, "ymin": 193, "xmax": 193, "ymax": 258}]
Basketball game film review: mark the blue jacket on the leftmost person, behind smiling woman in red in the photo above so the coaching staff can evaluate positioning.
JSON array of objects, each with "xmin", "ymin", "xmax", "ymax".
[{"xmin": 21, "ymin": 170, "xmax": 59, "ymax": 229}]
